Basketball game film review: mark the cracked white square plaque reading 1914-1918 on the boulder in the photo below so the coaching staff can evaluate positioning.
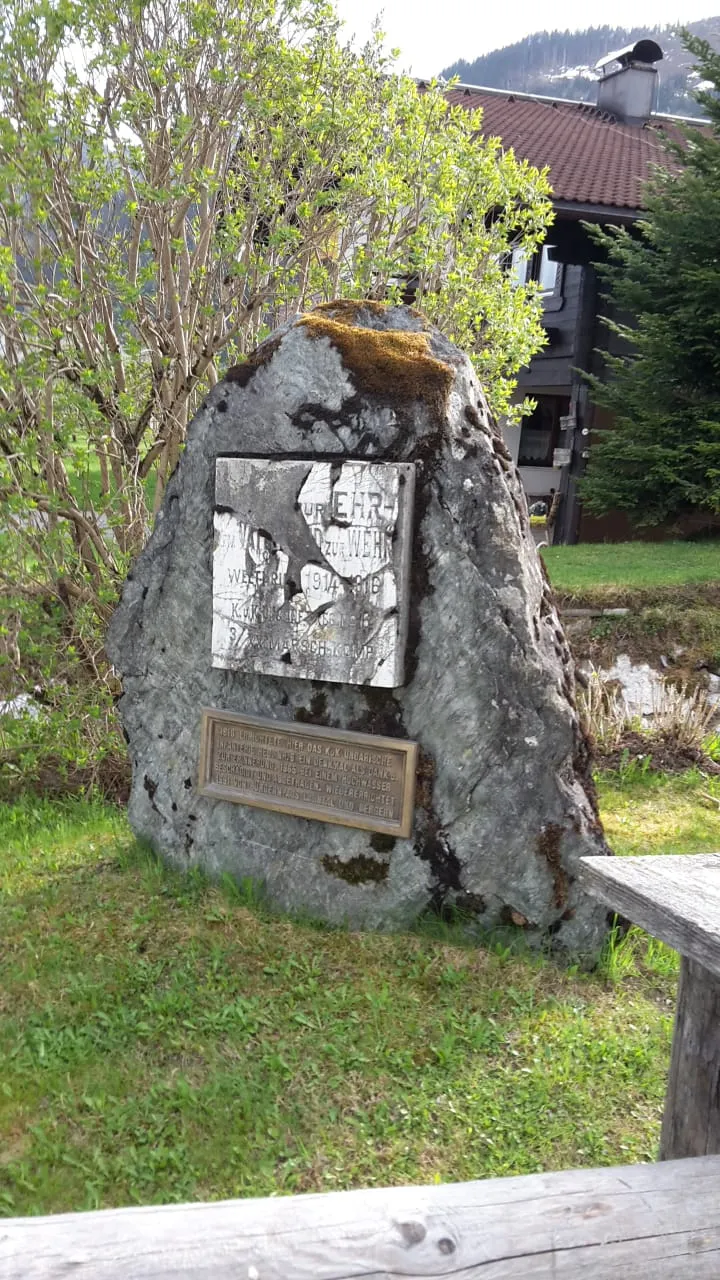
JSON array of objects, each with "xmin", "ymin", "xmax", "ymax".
[{"xmin": 213, "ymin": 458, "xmax": 415, "ymax": 689}]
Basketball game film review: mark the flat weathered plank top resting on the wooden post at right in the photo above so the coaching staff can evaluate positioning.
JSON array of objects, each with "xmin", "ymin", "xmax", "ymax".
[{"xmin": 579, "ymin": 854, "xmax": 720, "ymax": 974}]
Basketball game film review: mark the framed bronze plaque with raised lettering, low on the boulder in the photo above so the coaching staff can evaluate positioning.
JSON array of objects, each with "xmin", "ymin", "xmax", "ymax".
[{"xmin": 200, "ymin": 710, "xmax": 418, "ymax": 836}]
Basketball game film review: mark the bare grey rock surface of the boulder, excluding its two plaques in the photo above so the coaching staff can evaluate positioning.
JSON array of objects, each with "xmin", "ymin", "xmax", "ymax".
[{"xmin": 108, "ymin": 303, "xmax": 609, "ymax": 955}]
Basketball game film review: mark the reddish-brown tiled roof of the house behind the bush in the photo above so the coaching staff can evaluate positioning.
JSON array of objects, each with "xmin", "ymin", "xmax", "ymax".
[{"xmin": 447, "ymin": 88, "xmax": 679, "ymax": 210}]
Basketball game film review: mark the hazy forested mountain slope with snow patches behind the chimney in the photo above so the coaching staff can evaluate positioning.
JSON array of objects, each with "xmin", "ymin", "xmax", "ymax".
[{"xmin": 441, "ymin": 15, "xmax": 720, "ymax": 115}]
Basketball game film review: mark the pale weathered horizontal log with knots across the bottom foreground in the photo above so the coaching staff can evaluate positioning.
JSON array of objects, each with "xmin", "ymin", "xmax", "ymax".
[{"xmin": 0, "ymin": 1156, "xmax": 720, "ymax": 1280}]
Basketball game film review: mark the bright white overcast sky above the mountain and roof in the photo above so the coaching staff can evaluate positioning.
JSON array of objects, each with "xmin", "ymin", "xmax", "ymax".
[{"xmin": 336, "ymin": 0, "xmax": 720, "ymax": 77}]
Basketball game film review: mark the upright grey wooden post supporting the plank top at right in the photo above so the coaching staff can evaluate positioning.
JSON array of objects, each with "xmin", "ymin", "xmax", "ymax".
[{"xmin": 660, "ymin": 957, "xmax": 720, "ymax": 1160}]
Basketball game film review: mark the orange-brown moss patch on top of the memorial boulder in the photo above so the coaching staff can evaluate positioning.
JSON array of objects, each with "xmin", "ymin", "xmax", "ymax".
[{"xmin": 300, "ymin": 311, "xmax": 455, "ymax": 416}]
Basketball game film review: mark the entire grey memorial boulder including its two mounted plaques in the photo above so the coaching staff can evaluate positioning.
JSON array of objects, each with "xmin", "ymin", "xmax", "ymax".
[{"xmin": 108, "ymin": 303, "xmax": 607, "ymax": 955}]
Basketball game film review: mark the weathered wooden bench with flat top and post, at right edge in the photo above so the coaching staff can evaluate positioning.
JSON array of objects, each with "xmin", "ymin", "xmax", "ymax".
[{"xmin": 580, "ymin": 854, "xmax": 720, "ymax": 1160}]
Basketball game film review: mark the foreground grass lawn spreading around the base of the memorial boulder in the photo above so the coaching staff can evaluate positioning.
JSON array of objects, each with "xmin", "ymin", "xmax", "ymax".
[{"xmin": 0, "ymin": 771, "xmax": 720, "ymax": 1213}]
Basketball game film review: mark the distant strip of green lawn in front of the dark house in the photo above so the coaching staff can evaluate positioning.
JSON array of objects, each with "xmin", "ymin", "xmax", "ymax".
[{"xmin": 542, "ymin": 540, "xmax": 720, "ymax": 595}]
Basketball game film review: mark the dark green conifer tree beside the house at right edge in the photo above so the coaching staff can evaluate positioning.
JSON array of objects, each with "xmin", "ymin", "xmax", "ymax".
[{"xmin": 582, "ymin": 33, "xmax": 720, "ymax": 529}]
